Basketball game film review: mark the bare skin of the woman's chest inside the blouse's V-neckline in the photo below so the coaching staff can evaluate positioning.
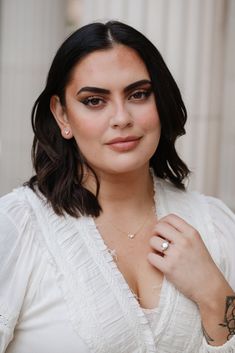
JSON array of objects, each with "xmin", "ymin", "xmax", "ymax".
[{"xmin": 95, "ymin": 219, "xmax": 163, "ymax": 308}]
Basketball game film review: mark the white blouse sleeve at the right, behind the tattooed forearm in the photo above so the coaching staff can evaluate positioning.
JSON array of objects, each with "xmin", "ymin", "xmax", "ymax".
[{"xmin": 200, "ymin": 197, "xmax": 235, "ymax": 353}]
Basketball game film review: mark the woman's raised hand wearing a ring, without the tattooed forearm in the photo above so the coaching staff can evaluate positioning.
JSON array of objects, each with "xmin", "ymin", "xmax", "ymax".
[{"xmin": 148, "ymin": 214, "xmax": 226, "ymax": 304}]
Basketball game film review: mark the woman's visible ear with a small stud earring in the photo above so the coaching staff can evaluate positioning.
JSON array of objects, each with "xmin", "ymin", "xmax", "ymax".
[{"xmin": 50, "ymin": 95, "xmax": 73, "ymax": 140}]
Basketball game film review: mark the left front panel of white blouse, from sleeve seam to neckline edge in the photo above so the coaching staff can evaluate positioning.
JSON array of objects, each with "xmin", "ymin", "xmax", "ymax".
[{"xmin": 23, "ymin": 186, "xmax": 156, "ymax": 353}]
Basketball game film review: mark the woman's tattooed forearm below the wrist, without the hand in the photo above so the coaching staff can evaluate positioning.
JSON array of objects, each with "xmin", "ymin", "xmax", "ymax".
[{"xmin": 199, "ymin": 285, "xmax": 235, "ymax": 346}]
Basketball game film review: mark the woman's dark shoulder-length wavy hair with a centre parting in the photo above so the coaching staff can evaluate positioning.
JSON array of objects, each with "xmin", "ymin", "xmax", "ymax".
[{"xmin": 26, "ymin": 21, "xmax": 189, "ymax": 217}]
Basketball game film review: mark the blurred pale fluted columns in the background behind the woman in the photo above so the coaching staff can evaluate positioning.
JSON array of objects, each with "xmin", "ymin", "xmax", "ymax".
[{"xmin": 0, "ymin": 0, "xmax": 235, "ymax": 210}]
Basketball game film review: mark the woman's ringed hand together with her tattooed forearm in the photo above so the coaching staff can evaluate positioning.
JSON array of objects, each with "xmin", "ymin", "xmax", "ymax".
[{"xmin": 148, "ymin": 214, "xmax": 235, "ymax": 345}]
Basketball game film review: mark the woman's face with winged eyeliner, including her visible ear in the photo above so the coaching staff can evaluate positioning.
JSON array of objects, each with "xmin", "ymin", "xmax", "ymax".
[{"xmin": 51, "ymin": 44, "xmax": 161, "ymax": 174}]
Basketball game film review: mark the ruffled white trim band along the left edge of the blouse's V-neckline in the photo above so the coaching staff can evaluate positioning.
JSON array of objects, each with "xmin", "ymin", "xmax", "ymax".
[{"xmin": 81, "ymin": 218, "xmax": 156, "ymax": 352}]
